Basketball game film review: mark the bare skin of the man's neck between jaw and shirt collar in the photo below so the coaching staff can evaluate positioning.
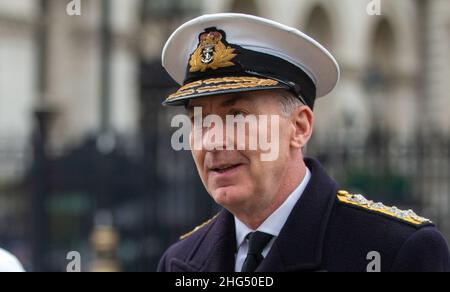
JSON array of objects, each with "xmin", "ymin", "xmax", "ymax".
[{"xmin": 231, "ymin": 159, "xmax": 306, "ymax": 230}]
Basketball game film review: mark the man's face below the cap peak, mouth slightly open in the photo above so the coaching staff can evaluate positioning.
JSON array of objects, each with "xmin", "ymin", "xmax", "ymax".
[{"xmin": 188, "ymin": 91, "xmax": 295, "ymax": 210}]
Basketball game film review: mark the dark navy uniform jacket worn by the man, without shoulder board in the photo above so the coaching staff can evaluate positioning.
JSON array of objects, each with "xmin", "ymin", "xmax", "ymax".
[{"xmin": 158, "ymin": 159, "xmax": 450, "ymax": 272}]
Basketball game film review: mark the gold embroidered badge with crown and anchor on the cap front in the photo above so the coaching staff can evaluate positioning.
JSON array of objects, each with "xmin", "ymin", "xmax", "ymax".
[{"xmin": 189, "ymin": 30, "xmax": 236, "ymax": 73}]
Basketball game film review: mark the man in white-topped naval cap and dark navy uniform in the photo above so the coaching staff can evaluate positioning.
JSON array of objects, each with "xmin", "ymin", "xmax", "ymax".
[{"xmin": 158, "ymin": 14, "xmax": 449, "ymax": 272}]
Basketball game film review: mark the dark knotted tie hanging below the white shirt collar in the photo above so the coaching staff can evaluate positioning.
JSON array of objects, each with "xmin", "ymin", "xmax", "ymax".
[{"xmin": 242, "ymin": 232, "xmax": 273, "ymax": 273}]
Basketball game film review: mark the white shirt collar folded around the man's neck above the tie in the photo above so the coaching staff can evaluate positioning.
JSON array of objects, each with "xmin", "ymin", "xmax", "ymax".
[{"xmin": 234, "ymin": 168, "xmax": 311, "ymax": 249}]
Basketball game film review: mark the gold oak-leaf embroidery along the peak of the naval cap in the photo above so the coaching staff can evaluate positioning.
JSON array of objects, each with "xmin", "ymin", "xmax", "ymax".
[{"xmin": 167, "ymin": 77, "xmax": 279, "ymax": 101}]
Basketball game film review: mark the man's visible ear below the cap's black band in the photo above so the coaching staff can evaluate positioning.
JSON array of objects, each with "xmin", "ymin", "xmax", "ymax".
[{"xmin": 291, "ymin": 106, "xmax": 314, "ymax": 149}]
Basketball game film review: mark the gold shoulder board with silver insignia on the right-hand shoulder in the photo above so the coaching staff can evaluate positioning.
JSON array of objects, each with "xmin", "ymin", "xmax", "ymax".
[{"xmin": 337, "ymin": 191, "xmax": 433, "ymax": 226}]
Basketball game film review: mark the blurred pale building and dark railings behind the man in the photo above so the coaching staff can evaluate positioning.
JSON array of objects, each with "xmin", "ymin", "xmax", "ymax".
[{"xmin": 0, "ymin": 0, "xmax": 450, "ymax": 271}]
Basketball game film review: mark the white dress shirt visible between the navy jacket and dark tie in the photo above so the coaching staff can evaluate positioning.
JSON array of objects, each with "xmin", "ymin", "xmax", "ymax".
[{"xmin": 234, "ymin": 168, "xmax": 311, "ymax": 272}]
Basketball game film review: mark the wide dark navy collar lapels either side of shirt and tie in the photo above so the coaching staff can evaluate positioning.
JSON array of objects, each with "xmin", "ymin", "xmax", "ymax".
[{"xmin": 171, "ymin": 159, "xmax": 338, "ymax": 272}]
